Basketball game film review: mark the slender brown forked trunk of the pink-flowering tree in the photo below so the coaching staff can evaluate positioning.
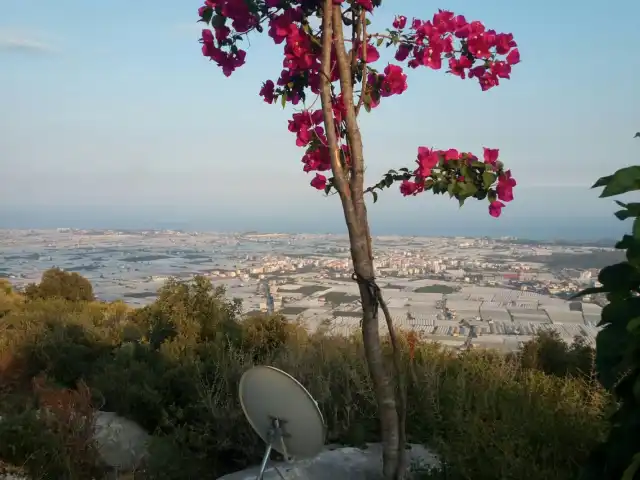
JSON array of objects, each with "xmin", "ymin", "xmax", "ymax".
[{"xmin": 321, "ymin": 0, "xmax": 404, "ymax": 480}]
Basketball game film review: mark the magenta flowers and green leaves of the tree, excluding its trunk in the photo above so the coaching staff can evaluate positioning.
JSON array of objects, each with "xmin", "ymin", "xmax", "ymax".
[{"xmin": 198, "ymin": 0, "xmax": 520, "ymax": 217}]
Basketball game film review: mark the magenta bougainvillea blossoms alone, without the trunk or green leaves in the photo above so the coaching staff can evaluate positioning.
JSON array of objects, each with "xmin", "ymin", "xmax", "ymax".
[{"xmin": 198, "ymin": 0, "xmax": 520, "ymax": 216}]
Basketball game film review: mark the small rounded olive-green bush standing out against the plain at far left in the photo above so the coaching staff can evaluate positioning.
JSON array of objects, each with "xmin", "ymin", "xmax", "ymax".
[{"xmin": 24, "ymin": 268, "xmax": 94, "ymax": 302}]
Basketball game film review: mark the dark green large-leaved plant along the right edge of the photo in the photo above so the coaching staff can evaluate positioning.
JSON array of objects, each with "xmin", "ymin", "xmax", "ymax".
[{"xmin": 578, "ymin": 135, "xmax": 640, "ymax": 480}]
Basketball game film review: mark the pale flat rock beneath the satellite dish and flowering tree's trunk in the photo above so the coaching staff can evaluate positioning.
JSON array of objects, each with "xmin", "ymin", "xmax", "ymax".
[{"xmin": 218, "ymin": 443, "xmax": 441, "ymax": 480}]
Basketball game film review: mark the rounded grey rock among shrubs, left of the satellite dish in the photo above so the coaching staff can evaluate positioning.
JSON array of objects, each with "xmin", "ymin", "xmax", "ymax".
[{"xmin": 94, "ymin": 411, "xmax": 150, "ymax": 471}]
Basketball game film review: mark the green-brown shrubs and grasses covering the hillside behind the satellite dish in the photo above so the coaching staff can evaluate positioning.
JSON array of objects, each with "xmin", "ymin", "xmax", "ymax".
[{"xmin": 0, "ymin": 272, "xmax": 610, "ymax": 480}]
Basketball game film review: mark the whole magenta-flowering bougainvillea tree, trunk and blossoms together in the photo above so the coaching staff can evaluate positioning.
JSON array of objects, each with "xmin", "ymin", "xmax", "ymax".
[{"xmin": 198, "ymin": 0, "xmax": 520, "ymax": 479}]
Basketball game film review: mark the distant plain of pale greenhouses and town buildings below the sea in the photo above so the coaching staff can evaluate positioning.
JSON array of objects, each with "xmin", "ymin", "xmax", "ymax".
[{"xmin": 0, "ymin": 228, "xmax": 623, "ymax": 351}]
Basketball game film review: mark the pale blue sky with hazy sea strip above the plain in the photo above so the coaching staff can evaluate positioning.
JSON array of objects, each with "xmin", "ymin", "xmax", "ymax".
[{"xmin": 0, "ymin": 0, "xmax": 640, "ymax": 237}]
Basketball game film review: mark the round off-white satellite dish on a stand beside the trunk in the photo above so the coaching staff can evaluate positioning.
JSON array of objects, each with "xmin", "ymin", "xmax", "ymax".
[{"xmin": 239, "ymin": 366, "xmax": 325, "ymax": 480}]
